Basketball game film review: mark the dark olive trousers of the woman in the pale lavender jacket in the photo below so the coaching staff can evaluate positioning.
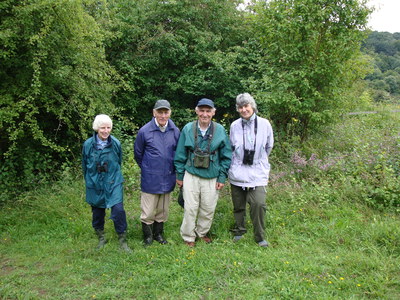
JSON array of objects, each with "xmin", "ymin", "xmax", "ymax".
[{"xmin": 231, "ymin": 184, "xmax": 267, "ymax": 242}]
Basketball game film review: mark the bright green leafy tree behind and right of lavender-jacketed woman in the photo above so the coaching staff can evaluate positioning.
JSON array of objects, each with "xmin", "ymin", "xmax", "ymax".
[{"xmin": 251, "ymin": 0, "xmax": 370, "ymax": 139}]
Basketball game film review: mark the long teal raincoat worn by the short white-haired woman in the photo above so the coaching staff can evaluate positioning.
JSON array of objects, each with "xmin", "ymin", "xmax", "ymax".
[{"xmin": 82, "ymin": 133, "xmax": 124, "ymax": 208}]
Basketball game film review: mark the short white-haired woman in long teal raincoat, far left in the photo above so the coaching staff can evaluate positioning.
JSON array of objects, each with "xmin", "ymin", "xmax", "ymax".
[{"xmin": 82, "ymin": 115, "xmax": 131, "ymax": 252}]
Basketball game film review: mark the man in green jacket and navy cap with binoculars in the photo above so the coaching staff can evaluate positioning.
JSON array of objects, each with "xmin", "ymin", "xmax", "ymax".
[{"xmin": 174, "ymin": 98, "xmax": 232, "ymax": 247}]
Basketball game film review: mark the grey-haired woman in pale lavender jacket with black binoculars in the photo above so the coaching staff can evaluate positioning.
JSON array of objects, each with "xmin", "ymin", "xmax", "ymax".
[{"xmin": 229, "ymin": 93, "xmax": 274, "ymax": 247}]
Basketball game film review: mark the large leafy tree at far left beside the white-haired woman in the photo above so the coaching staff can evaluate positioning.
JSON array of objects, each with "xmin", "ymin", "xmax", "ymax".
[{"xmin": 0, "ymin": 0, "xmax": 118, "ymax": 199}]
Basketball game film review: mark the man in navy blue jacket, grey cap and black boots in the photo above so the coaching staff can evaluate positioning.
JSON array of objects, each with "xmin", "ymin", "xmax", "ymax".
[{"xmin": 135, "ymin": 100, "xmax": 180, "ymax": 246}]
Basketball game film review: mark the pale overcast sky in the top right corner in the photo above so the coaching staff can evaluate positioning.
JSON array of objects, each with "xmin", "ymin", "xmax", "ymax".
[{"xmin": 368, "ymin": 0, "xmax": 400, "ymax": 33}]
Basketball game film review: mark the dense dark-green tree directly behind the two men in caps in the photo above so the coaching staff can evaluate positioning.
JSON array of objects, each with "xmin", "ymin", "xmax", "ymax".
[{"xmin": 107, "ymin": 0, "xmax": 248, "ymax": 126}]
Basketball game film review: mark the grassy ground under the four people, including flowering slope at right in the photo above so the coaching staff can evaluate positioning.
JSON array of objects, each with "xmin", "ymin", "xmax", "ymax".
[{"xmin": 0, "ymin": 107, "xmax": 400, "ymax": 299}]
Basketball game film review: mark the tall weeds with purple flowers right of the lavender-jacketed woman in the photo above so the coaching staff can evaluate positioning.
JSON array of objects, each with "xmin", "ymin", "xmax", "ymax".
[{"xmin": 271, "ymin": 108, "xmax": 400, "ymax": 213}]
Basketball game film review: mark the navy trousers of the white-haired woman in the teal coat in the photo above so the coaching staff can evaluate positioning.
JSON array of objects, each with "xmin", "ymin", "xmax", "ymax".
[{"xmin": 92, "ymin": 202, "xmax": 127, "ymax": 233}]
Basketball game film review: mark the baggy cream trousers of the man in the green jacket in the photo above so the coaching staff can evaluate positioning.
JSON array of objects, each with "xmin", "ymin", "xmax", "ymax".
[{"xmin": 181, "ymin": 172, "xmax": 219, "ymax": 242}]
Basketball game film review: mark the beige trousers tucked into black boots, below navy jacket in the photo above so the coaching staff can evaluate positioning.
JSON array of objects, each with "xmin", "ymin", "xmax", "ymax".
[{"xmin": 140, "ymin": 192, "xmax": 171, "ymax": 225}]
